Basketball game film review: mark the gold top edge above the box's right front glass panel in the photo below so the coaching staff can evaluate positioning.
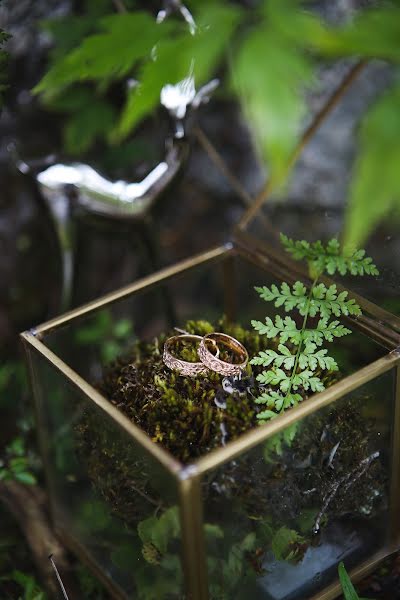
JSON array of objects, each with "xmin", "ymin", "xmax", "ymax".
[{"xmin": 193, "ymin": 351, "xmax": 400, "ymax": 474}]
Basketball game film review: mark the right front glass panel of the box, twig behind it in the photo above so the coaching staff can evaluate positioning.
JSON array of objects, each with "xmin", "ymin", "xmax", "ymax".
[{"xmin": 202, "ymin": 370, "xmax": 394, "ymax": 600}]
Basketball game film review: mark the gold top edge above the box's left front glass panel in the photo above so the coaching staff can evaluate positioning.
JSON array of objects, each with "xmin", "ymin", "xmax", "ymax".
[{"xmin": 20, "ymin": 332, "xmax": 183, "ymax": 478}]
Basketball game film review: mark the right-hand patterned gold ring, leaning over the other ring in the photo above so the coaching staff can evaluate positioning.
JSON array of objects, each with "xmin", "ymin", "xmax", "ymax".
[{"xmin": 198, "ymin": 333, "xmax": 249, "ymax": 376}]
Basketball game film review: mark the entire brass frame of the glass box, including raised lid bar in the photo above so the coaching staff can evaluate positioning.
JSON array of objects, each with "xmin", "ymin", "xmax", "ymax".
[{"xmin": 21, "ymin": 62, "xmax": 400, "ymax": 600}]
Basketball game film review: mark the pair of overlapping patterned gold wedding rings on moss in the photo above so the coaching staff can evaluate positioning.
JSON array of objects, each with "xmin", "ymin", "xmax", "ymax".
[{"xmin": 163, "ymin": 332, "xmax": 249, "ymax": 377}]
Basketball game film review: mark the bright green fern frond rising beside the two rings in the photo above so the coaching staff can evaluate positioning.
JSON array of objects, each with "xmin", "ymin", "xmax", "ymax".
[{"xmin": 251, "ymin": 234, "xmax": 378, "ymax": 421}]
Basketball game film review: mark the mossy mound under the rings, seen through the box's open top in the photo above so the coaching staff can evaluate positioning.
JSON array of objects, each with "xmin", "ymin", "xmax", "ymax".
[{"xmin": 100, "ymin": 320, "xmax": 274, "ymax": 462}]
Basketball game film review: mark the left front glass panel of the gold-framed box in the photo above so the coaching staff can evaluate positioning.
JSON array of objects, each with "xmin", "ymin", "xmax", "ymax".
[{"xmin": 28, "ymin": 352, "xmax": 183, "ymax": 600}]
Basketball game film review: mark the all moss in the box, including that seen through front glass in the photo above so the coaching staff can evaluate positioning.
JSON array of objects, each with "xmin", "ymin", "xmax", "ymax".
[{"xmin": 77, "ymin": 320, "xmax": 387, "ymax": 539}]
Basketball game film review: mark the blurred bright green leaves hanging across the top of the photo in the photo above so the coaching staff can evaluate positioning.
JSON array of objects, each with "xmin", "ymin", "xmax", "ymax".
[{"xmin": 35, "ymin": 0, "xmax": 400, "ymax": 245}]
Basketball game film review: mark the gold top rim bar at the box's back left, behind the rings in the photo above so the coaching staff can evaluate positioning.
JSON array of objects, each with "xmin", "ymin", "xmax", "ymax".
[{"xmin": 34, "ymin": 243, "xmax": 232, "ymax": 337}]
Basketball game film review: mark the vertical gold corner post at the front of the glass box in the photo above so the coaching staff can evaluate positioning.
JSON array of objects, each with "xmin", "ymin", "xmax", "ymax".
[{"xmin": 178, "ymin": 474, "xmax": 209, "ymax": 600}]
